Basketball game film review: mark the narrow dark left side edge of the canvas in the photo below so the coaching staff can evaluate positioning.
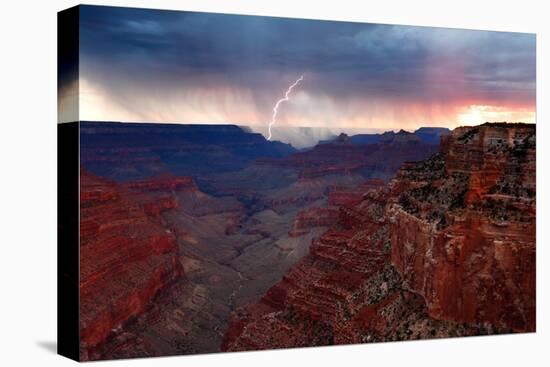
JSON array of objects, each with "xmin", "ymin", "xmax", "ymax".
[{"xmin": 57, "ymin": 7, "xmax": 80, "ymax": 360}]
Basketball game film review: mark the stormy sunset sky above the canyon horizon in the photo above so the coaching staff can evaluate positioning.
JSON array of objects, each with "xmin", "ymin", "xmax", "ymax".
[{"xmin": 59, "ymin": 6, "xmax": 536, "ymax": 141}]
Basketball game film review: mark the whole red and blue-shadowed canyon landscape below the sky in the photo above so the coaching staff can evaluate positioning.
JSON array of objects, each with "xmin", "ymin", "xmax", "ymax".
[{"xmin": 80, "ymin": 122, "xmax": 536, "ymax": 360}]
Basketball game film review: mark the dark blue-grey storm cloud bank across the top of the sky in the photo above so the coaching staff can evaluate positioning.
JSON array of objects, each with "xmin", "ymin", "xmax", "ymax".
[{"xmin": 62, "ymin": 6, "xmax": 535, "ymax": 129}]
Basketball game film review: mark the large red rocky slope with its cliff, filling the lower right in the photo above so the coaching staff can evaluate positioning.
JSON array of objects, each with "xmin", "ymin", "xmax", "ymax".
[{"xmin": 222, "ymin": 124, "xmax": 535, "ymax": 351}]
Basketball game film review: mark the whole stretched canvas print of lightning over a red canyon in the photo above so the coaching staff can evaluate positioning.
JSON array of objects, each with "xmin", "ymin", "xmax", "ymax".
[{"xmin": 58, "ymin": 5, "xmax": 536, "ymax": 361}]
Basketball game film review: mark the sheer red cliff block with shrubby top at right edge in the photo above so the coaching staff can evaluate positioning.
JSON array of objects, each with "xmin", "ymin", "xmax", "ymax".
[{"xmin": 389, "ymin": 124, "xmax": 536, "ymax": 331}]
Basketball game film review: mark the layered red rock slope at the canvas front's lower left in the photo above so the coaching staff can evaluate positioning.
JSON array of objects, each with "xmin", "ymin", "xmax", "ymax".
[{"xmin": 80, "ymin": 171, "xmax": 185, "ymax": 360}]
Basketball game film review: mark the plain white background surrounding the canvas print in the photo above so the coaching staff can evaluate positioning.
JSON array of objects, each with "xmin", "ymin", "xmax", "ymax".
[{"xmin": 0, "ymin": 0, "xmax": 550, "ymax": 367}]
